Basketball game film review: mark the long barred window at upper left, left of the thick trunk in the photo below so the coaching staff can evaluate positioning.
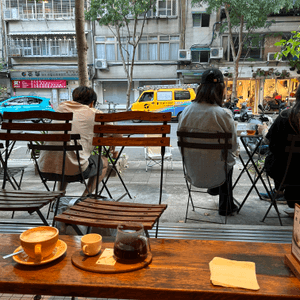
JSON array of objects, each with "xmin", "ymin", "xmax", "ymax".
[{"xmin": 8, "ymin": 35, "xmax": 77, "ymax": 57}]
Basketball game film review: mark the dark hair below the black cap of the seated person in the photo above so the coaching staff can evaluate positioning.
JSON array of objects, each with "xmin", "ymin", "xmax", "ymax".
[{"xmin": 194, "ymin": 82, "xmax": 225, "ymax": 106}]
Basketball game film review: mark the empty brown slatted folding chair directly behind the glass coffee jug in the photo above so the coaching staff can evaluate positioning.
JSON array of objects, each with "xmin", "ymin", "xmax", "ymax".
[{"xmin": 55, "ymin": 111, "xmax": 171, "ymax": 237}]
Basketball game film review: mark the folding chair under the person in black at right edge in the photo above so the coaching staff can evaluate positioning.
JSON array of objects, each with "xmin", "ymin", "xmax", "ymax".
[{"xmin": 262, "ymin": 134, "xmax": 300, "ymax": 226}]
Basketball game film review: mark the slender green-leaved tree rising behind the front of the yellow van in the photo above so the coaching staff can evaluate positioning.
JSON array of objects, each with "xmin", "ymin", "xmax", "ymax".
[{"xmin": 86, "ymin": 0, "xmax": 156, "ymax": 108}]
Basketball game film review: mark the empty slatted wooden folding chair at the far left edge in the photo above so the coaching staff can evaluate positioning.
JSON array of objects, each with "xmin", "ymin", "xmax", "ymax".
[{"xmin": 0, "ymin": 111, "xmax": 79, "ymax": 226}]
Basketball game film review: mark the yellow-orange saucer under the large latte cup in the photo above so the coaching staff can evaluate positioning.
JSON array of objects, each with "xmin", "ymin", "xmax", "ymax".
[{"xmin": 13, "ymin": 240, "xmax": 67, "ymax": 266}]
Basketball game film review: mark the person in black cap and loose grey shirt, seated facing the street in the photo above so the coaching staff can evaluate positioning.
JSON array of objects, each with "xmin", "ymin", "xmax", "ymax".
[{"xmin": 177, "ymin": 68, "xmax": 238, "ymax": 216}]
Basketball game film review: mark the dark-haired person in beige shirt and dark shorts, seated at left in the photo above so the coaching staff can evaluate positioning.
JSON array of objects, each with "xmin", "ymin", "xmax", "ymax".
[{"xmin": 39, "ymin": 86, "xmax": 108, "ymax": 196}]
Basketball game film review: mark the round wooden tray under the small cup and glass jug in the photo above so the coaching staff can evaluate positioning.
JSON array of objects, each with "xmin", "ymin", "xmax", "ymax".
[{"xmin": 72, "ymin": 245, "xmax": 152, "ymax": 274}]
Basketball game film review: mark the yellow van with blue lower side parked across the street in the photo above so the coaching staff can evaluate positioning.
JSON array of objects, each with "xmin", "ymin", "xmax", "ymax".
[{"xmin": 130, "ymin": 88, "xmax": 196, "ymax": 117}]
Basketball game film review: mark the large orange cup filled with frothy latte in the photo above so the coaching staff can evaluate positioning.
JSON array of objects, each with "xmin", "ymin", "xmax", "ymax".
[{"xmin": 20, "ymin": 226, "xmax": 59, "ymax": 261}]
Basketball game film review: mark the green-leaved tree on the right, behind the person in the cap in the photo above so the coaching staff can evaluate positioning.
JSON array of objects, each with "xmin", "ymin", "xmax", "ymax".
[{"xmin": 192, "ymin": 0, "xmax": 300, "ymax": 99}]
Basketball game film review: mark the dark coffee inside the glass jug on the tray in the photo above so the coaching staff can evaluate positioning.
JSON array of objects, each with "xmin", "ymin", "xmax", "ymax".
[{"xmin": 114, "ymin": 240, "xmax": 147, "ymax": 261}]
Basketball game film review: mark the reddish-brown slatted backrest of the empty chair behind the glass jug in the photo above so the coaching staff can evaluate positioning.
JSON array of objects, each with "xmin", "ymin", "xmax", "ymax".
[{"xmin": 93, "ymin": 111, "xmax": 172, "ymax": 201}]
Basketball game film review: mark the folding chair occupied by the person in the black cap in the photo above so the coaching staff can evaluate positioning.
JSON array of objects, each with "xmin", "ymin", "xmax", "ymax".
[{"xmin": 177, "ymin": 131, "xmax": 233, "ymax": 224}]
